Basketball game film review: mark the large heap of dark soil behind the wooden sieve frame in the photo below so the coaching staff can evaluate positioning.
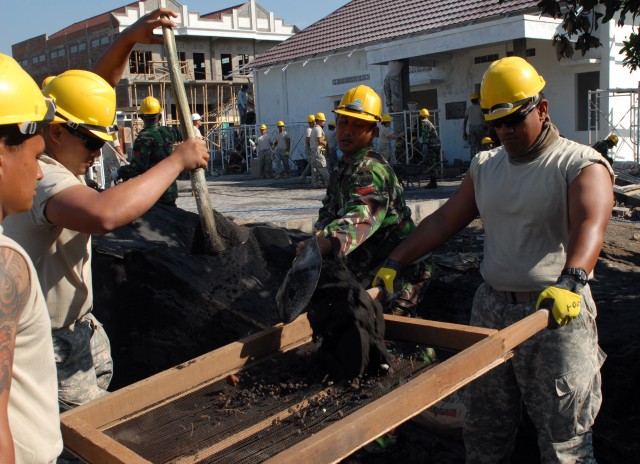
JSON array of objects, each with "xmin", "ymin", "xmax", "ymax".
[{"xmin": 93, "ymin": 205, "xmax": 308, "ymax": 390}]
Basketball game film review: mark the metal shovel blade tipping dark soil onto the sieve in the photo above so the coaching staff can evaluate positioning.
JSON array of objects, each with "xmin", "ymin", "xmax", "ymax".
[{"xmin": 276, "ymin": 236, "xmax": 322, "ymax": 324}]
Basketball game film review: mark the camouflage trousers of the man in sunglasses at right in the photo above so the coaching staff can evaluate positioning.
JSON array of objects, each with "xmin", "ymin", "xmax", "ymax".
[{"xmin": 463, "ymin": 283, "xmax": 605, "ymax": 464}]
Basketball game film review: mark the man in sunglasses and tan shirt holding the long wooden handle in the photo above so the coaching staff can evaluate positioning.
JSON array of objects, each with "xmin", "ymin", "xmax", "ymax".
[{"xmin": 3, "ymin": 8, "xmax": 209, "ymax": 448}]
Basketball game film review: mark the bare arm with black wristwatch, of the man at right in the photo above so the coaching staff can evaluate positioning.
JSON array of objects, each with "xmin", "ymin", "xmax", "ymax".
[{"xmin": 565, "ymin": 163, "xmax": 613, "ymax": 274}]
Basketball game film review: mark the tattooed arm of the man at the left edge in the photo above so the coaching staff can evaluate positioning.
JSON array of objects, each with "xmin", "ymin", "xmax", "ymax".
[{"xmin": 0, "ymin": 247, "xmax": 30, "ymax": 463}]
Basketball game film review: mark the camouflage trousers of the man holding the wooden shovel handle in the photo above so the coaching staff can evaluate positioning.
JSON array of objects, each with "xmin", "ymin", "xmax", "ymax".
[{"xmin": 53, "ymin": 313, "xmax": 113, "ymax": 412}]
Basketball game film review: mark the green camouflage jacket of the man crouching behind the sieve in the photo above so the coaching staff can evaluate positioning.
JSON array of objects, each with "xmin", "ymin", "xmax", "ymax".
[{"xmin": 314, "ymin": 147, "xmax": 415, "ymax": 272}]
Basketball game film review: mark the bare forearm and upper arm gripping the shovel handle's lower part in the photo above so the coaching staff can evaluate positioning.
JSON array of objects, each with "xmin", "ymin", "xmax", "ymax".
[{"xmin": 45, "ymin": 138, "xmax": 209, "ymax": 235}]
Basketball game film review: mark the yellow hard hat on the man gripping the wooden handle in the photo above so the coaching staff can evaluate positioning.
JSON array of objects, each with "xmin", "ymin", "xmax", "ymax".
[{"xmin": 42, "ymin": 69, "xmax": 118, "ymax": 141}]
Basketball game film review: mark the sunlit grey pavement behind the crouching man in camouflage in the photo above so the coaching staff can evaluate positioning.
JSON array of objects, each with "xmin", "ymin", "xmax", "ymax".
[{"xmin": 176, "ymin": 174, "xmax": 460, "ymax": 232}]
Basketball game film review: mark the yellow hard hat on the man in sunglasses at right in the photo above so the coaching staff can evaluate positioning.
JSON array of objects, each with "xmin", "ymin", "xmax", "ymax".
[{"xmin": 480, "ymin": 56, "xmax": 546, "ymax": 121}]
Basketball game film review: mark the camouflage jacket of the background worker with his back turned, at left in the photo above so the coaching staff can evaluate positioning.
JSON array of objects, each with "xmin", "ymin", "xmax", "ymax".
[{"xmin": 118, "ymin": 124, "xmax": 182, "ymax": 205}]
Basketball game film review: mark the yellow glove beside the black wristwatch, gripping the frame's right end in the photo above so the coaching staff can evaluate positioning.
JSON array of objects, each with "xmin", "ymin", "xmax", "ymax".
[{"xmin": 536, "ymin": 269, "xmax": 586, "ymax": 328}]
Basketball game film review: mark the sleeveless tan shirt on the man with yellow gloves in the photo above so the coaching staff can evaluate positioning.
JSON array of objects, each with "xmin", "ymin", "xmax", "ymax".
[{"xmin": 469, "ymin": 137, "xmax": 613, "ymax": 292}]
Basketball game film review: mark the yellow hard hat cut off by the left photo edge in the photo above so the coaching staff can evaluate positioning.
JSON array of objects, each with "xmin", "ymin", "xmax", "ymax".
[{"xmin": 0, "ymin": 53, "xmax": 55, "ymax": 135}]
